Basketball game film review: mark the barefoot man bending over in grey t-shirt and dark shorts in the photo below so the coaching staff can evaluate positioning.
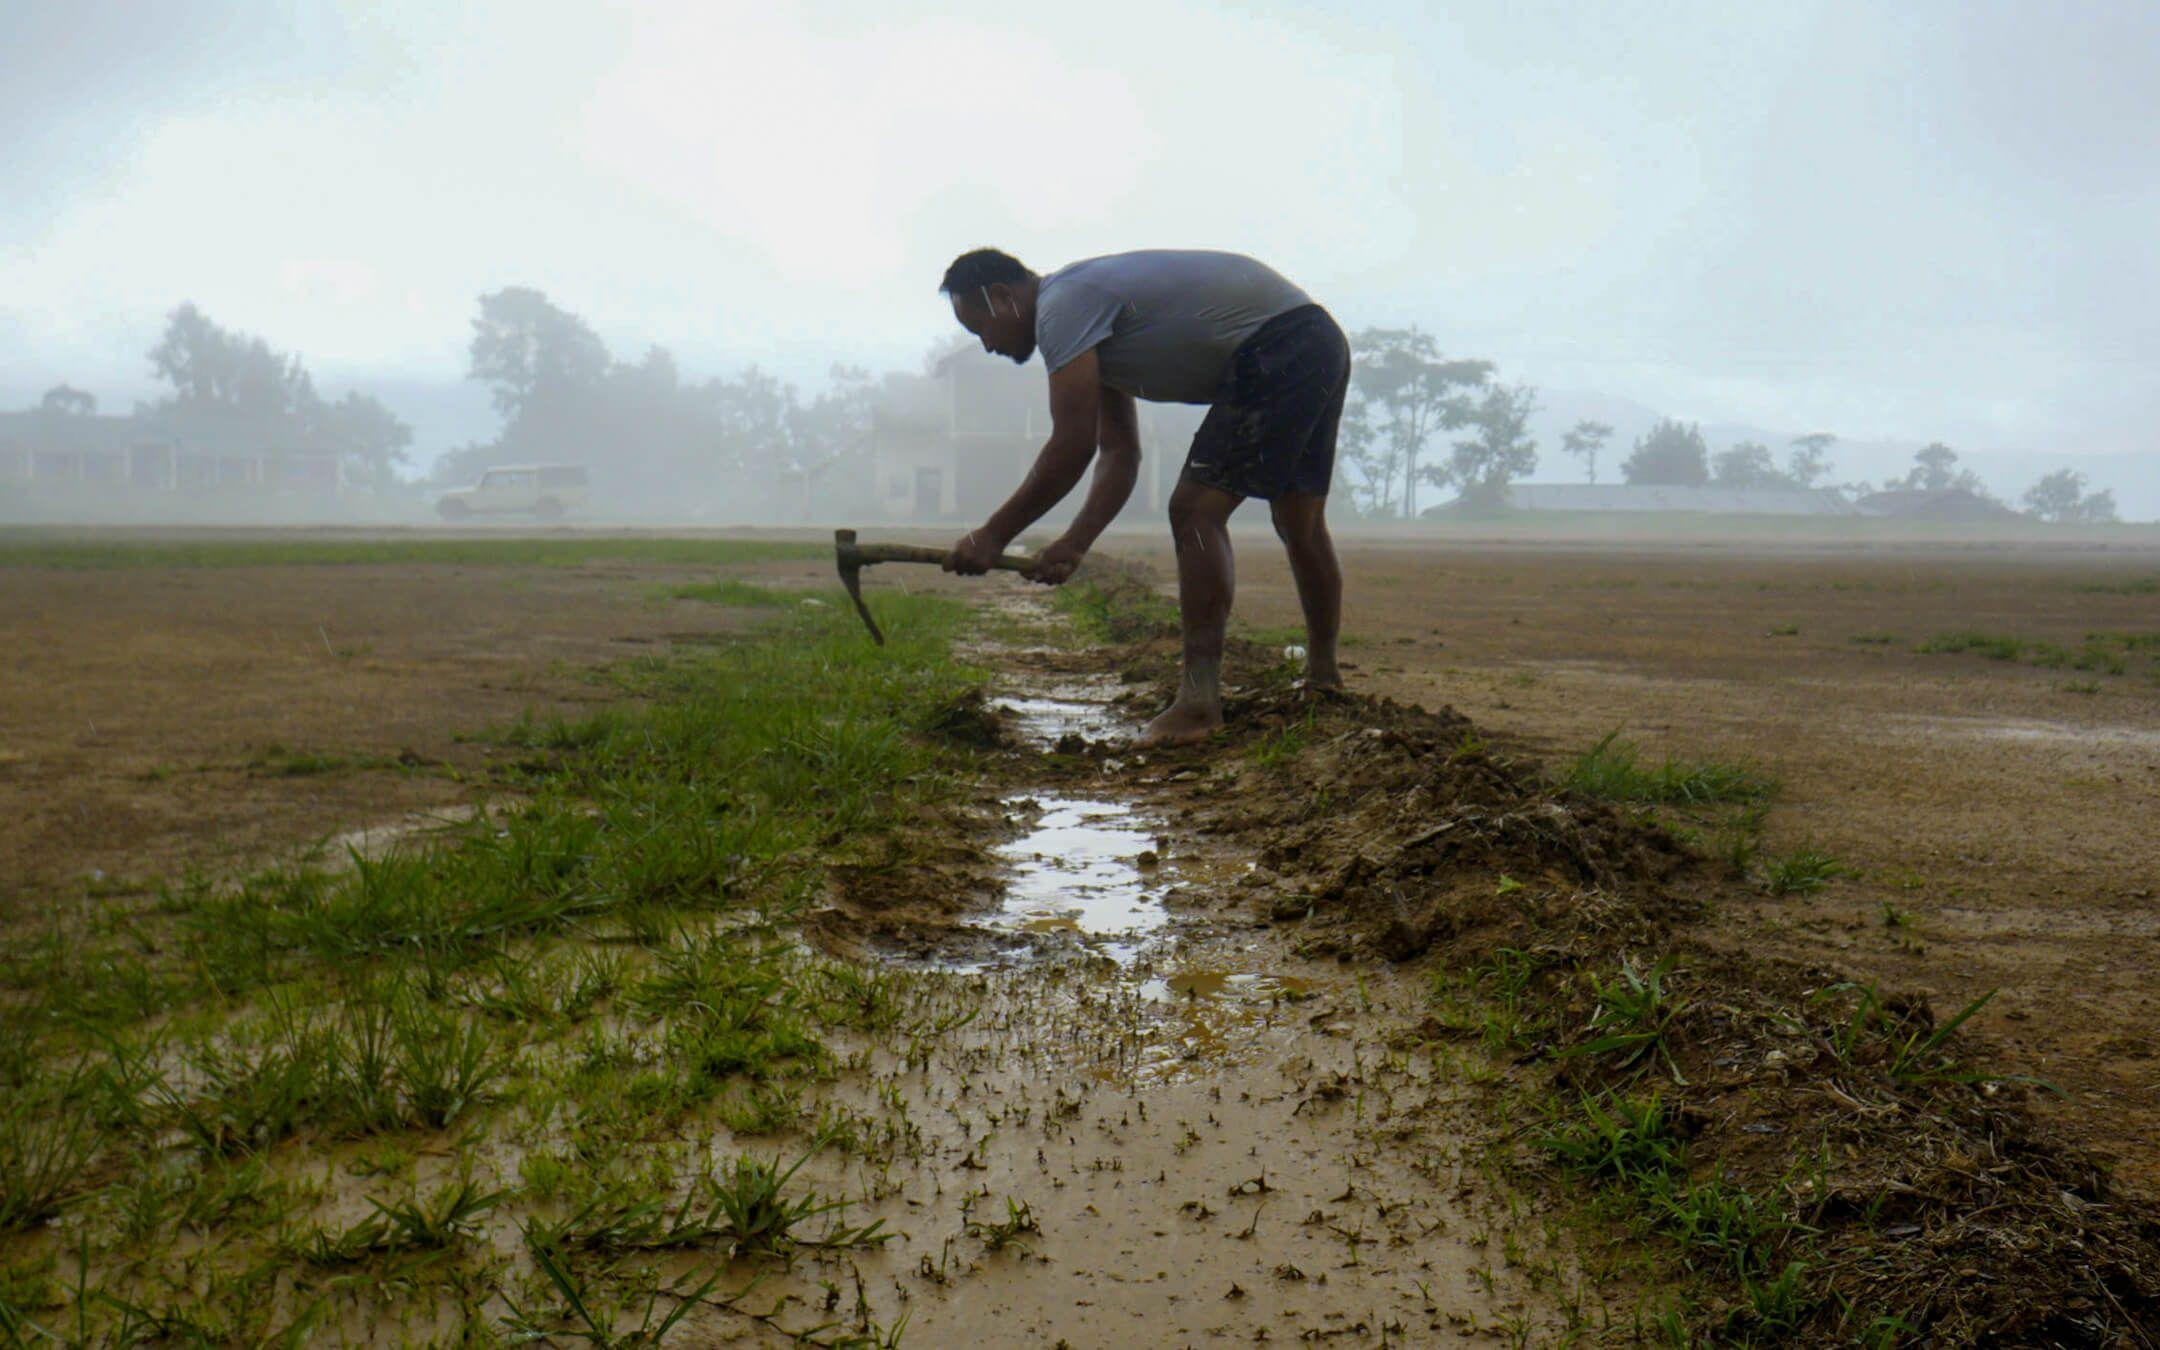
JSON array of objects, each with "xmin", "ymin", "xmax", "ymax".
[{"xmin": 937, "ymin": 248, "xmax": 1350, "ymax": 745}]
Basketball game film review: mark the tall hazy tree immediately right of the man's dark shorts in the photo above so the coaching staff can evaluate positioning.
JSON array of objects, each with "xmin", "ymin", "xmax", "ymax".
[{"xmin": 1344, "ymin": 326, "xmax": 1493, "ymax": 518}]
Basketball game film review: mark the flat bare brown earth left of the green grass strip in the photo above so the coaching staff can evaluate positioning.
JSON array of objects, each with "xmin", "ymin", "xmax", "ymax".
[{"xmin": 0, "ymin": 566, "xmax": 730, "ymax": 896}]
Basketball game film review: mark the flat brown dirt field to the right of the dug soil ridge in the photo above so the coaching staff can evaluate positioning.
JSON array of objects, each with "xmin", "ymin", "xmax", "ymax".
[{"xmin": 1200, "ymin": 540, "xmax": 2160, "ymax": 1192}]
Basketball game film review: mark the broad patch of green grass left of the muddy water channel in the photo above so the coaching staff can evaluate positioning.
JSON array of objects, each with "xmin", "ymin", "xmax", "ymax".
[{"xmin": 0, "ymin": 594, "xmax": 981, "ymax": 1344}]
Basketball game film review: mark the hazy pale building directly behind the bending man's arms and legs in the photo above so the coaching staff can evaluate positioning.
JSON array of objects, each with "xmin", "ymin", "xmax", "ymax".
[{"xmin": 870, "ymin": 348, "xmax": 1207, "ymax": 521}]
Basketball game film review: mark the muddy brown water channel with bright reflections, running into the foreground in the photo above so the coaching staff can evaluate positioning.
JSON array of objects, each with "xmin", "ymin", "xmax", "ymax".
[{"xmin": 794, "ymin": 665, "xmax": 1575, "ymax": 1346}]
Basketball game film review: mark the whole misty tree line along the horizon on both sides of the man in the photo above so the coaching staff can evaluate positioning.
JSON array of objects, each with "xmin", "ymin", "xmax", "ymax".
[{"xmin": 0, "ymin": 304, "xmax": 2117, "ymax": 523}]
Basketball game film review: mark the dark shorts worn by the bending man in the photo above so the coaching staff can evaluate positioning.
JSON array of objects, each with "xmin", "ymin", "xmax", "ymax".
[{"xmin": 1186, "ymin": 305, "xmax": 1350, "ymax": 499}]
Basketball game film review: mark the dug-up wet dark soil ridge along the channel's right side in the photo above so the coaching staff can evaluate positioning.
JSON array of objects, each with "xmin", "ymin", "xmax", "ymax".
[{"xmin": 1049, "ymin": 557, "xmax": 2160, "ymax": 1346}]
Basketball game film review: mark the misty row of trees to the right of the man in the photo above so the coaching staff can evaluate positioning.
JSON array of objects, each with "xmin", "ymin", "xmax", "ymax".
[{"xmin": 1337, "ymin": 326, "xmax": 2117, "ymax": 523}]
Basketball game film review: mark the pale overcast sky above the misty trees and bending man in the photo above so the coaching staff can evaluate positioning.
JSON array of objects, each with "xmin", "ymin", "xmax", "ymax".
[{"xmin": 0, "ymin": 0, "xmax": 2160, "ymax": 507}]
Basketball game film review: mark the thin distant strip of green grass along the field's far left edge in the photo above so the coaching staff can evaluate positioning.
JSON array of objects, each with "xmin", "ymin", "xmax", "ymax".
[{"xmin": 0, "ymin": 534, "xmax": 832, "ymax": 570}]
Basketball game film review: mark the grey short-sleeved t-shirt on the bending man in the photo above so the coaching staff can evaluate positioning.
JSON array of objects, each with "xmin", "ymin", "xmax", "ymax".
[{"xmin": 1035, "ymin": 248, "xmax": 1311, "ymax": 404}]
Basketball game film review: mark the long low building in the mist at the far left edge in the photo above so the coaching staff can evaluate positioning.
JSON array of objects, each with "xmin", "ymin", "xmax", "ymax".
[{"xmin": 0, "ymin": 408, "xmax": 346, "ymax": 499}]
